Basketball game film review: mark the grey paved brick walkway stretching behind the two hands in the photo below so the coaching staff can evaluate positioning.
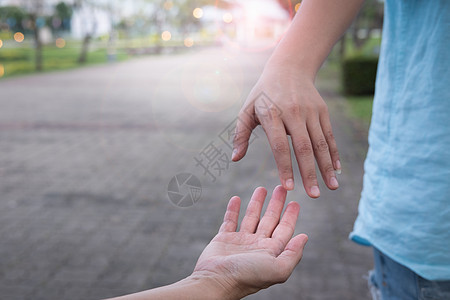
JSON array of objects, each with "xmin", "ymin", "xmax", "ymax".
[{"xmin": 0, "ymin": 49, "xmax": 371, "ymax": 300}]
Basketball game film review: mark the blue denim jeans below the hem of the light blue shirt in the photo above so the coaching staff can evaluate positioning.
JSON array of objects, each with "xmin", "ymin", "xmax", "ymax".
[{"xmin": 369, "ymin": 248, "xmax": 450, "ymax": 300}]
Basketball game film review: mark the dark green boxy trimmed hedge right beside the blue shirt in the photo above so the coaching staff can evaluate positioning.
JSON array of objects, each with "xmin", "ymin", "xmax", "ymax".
[{"xmin": 342, "ymin": 57, "xmax": 378, "ymax": 95}]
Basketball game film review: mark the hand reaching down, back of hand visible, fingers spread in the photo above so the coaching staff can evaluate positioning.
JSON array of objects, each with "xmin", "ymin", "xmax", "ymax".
[{"xmin": 232, "ymin": 63, "xmax": 341, "ymax": 198}]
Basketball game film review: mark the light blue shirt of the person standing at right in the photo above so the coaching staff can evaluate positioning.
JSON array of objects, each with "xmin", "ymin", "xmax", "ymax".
[{"xmin": 350, "ymin": 0, "xmax": 450, "ymax": 280}]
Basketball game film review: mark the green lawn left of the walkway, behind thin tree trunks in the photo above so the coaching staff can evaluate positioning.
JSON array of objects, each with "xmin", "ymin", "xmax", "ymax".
[{"xmin": 0, "ymin": 43, "xmax": 128, "ymax": 78}]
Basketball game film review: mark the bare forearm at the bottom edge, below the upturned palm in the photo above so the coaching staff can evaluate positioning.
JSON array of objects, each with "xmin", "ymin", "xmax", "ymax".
[{"xmin": 110, "ymin": 275, "xmax": 240, "ymax": 300}]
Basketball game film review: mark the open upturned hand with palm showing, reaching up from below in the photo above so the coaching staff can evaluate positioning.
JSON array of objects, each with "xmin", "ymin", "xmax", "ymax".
[{"xmin": 193, "ymin": 186, "xmax": 308, "ymax": 298}]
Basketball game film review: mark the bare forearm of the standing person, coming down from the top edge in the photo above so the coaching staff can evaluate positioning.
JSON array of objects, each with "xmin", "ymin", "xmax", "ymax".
[{"xmin": 269, "ymin": 0, "xmax": 364, "ymax": 79}]
